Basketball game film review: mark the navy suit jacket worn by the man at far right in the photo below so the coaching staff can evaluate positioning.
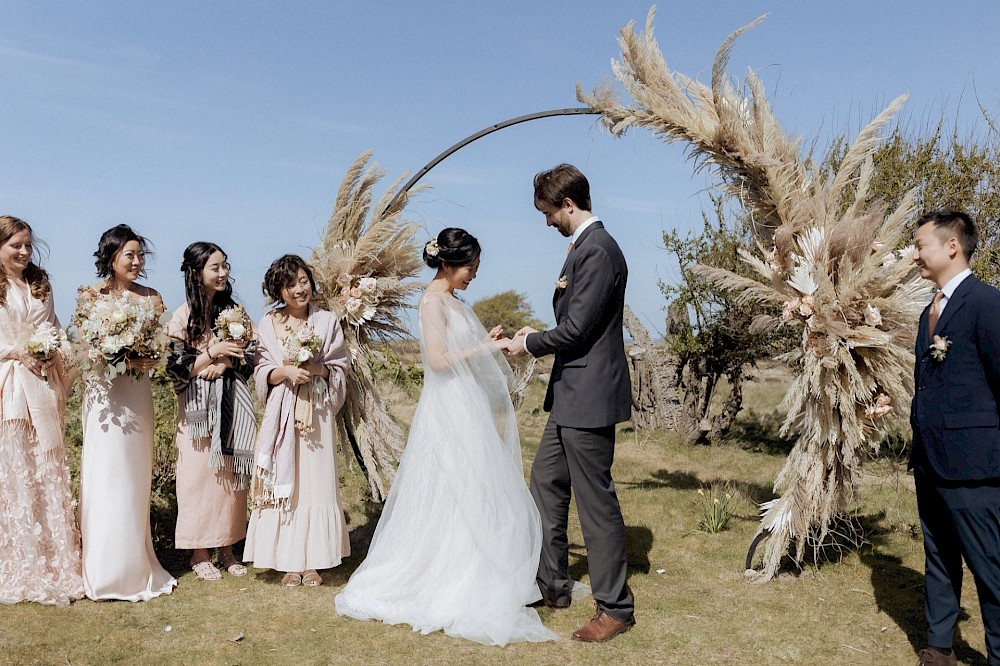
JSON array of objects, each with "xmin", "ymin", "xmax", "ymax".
[{"xmin": 910, "ymin": 275, "xmax": 1000, "ymax": 481}]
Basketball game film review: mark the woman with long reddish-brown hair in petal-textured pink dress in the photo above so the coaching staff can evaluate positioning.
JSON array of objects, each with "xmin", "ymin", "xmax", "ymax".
[{"xmin": 0, "ymin": 215, "xmax": 83, "ymax": 606}]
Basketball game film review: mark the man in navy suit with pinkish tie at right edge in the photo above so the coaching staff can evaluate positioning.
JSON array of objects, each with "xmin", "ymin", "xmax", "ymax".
[{"xmin": 910, "ymin": 211, "xmax": 1000, "ymax": 666}]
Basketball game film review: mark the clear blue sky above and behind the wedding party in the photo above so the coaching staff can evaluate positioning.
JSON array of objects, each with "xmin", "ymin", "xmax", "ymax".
[{"xmin": 0, "ymin": 0, "xmax": 1000, "ymax": 331}]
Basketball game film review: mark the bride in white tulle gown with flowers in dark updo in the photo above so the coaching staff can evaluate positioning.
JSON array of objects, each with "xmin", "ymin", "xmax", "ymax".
[{"xmin": 336, "ymin": 229, "xmax": 556, "ymax": 645}]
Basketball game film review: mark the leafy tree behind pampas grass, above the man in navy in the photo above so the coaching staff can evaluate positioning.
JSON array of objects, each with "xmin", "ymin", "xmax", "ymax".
[{"xmin": 824, "ymin": 117, "xmax": 1000, "ymax": 286}]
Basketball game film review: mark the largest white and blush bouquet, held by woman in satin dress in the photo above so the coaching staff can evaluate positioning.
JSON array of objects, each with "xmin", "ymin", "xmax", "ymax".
[{"xmin": 76, "ymin": 295, "xmax": 170, "ymax": 380}]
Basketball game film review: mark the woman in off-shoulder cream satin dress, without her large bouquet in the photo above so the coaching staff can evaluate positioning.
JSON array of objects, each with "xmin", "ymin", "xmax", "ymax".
[{"xmin": 78, "ymin": 224, "xmax": 177, "ymax": 601}]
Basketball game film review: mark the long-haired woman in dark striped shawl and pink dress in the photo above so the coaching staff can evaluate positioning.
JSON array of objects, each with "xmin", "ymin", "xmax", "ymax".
[{"xmin": 167, "ymin": 242, "xmax": 257, "ymax": 580}]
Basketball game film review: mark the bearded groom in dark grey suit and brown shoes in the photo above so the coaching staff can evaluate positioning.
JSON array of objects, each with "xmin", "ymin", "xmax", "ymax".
[{"xmin": 508, "ymin": 164, "xmax": 635, "ymax": 642}]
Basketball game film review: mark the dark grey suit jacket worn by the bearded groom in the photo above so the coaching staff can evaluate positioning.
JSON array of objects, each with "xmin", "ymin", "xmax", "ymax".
[{"xmin": 525, "ymin": 222, "xmax": 632, "ymax": 428}]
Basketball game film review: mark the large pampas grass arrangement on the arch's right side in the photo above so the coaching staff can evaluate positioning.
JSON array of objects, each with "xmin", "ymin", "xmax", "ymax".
[{"xmin": 577, "ymin": 7, "xmax": 930, "ymax": 582}]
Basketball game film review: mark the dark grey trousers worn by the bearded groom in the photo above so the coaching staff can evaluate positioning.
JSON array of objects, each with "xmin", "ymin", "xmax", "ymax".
[{"xmin": 531, "ymin": 418, "xmax": 633, "ymax": 623}]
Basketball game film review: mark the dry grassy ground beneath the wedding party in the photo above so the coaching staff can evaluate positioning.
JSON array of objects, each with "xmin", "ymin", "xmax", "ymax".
[{"xmin": 0, "ymin": 377, "xmax": 985, "ymax": 666}]
